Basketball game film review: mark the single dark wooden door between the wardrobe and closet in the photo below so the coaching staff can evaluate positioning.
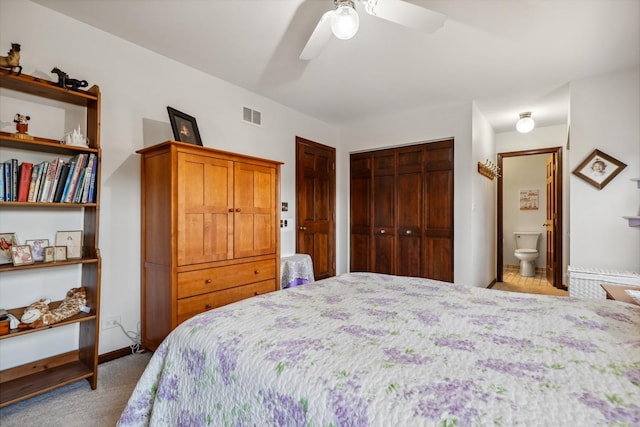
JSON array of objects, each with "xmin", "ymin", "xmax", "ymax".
[{"xmin": 296, "ymin": 137, "xmax": 336, "ymax": 280}]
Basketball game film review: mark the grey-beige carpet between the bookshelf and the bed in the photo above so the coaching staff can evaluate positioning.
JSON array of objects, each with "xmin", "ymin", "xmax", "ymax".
[{"xmin": 0, "ymin": 352, "xmax": 151, "ymax": 427}]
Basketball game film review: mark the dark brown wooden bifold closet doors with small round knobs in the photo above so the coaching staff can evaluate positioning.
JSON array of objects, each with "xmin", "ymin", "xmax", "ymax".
[{"xmin": 350, "ymin": 140, "xmax": 454, "ymax": 282}]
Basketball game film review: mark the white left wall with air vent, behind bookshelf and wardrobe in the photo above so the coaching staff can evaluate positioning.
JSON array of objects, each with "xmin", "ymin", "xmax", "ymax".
[{"xmin": 0, "ymin": 0, "xmax": 345, "ymax": 369}]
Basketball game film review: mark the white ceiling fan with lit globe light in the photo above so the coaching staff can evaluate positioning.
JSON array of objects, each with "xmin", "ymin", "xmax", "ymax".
[{"xmin": 300, "ymin": 0, "xmax": 447, "ymax": 61}]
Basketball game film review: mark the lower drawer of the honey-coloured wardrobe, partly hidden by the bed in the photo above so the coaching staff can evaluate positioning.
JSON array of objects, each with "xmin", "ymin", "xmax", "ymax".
[{"xmin": 178, "ymin": 279, "xmax": 276, "ymax": 324}]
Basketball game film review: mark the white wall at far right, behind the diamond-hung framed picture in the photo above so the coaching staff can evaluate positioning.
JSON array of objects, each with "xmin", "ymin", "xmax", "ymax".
[{"xmin": 569, "ymin": 68, "xmax": 640, "ymax": 272}]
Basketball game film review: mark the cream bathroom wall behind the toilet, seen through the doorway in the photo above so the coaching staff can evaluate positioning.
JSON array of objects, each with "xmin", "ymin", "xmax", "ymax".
[{"xmin": 502, "ymin": 154, "xmax": 549, "ymax": 268}]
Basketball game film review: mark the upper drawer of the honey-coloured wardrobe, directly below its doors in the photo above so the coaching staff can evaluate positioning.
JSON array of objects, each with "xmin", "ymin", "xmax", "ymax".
[{"xmin": 178, "ymin": 260, "xmax": 276, "ymax": 298}]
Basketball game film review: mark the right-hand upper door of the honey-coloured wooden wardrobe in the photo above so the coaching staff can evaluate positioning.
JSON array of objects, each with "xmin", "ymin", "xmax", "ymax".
[{"xmin": 233, "ymin": 162, "xmax": 277, "ymax": 258}]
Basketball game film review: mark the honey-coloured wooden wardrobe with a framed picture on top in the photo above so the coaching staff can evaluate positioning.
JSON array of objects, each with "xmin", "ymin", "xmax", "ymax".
[{"xmin": 138, "ymin": 141, "xmax": 281, "ymax": 350}]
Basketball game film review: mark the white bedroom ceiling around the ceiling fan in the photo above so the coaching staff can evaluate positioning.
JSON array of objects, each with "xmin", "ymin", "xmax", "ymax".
[{"xmin": 35, "ymin": 0, "xmax": 640, "ymax": 132}]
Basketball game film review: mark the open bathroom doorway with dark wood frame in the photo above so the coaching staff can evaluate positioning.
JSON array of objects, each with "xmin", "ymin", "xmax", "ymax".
[{"xmin": 496, "ymin": 147, "xmax": 564, "ymax": 289}]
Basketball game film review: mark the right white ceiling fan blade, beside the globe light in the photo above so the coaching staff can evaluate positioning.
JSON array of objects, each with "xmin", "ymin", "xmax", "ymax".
[{"xmin": 361, "ymin": 0, "xmax": 447, "ymax": 33}]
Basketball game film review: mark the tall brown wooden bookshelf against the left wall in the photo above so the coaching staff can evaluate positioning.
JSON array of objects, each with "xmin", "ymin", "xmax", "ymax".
[{"xmin": 0, "ymin": 69, "xmax": 102, "ymax": 407}]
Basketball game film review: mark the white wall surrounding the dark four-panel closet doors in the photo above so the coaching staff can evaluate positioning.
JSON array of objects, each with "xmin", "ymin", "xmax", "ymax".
[{"xmin": 337, "ymin": 103, "xmax": 495, "ymax": 287}]
